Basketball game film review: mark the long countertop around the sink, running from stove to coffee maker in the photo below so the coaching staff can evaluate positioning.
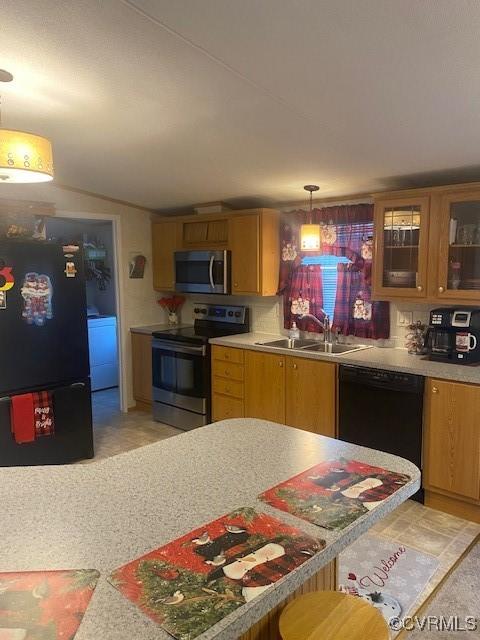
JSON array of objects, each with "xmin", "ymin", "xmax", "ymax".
[{"xmin": 210, "ymin": 333, "xmax": 480, "ymax": 384}]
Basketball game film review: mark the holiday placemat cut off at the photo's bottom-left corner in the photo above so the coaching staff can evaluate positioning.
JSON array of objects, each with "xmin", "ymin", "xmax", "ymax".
[{"xmin": 0, "ymin": 569, "xmax": 100, "ymax": 640}]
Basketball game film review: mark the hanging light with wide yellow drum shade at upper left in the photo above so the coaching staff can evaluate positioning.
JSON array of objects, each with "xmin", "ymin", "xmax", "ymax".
[{"xmin": 0, "ymin": 69, "xmax": 53, "ymax": 184}]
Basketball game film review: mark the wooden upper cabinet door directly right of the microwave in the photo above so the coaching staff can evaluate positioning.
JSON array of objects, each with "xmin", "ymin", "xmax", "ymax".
[{"xmin": 228, "ymin": 215, "xmax": 260, "ymax": 295}]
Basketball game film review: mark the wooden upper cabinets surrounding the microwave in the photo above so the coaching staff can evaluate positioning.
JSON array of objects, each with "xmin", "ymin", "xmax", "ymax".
[{"xmin": 152, "ymin": 209, "xmax": 280, "ymax": 296}]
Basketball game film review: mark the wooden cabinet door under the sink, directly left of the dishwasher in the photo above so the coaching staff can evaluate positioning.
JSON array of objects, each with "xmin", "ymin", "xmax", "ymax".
[{"xmin": 285, "ymin": 356, "xmax": 336, "ymax": 438}]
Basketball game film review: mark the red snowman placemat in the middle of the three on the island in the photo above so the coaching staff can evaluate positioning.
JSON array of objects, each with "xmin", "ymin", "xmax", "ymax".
[{"xmin": 109, "ymin": 508, "xmax": 325, "ymax": 640}]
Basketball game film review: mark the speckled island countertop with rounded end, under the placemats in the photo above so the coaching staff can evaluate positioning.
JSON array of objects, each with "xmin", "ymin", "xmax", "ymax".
[{"xmin": 0, "ymin": 419, "xmax": 420, "ymax": 640}]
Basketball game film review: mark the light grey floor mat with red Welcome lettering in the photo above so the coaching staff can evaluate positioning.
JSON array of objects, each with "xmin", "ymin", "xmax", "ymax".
[{"xmin": 338, "ymin": 533, "xmax": 440, "ymax": 622}]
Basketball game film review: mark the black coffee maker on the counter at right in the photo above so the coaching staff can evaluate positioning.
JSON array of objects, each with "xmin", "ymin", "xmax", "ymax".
[{"xmin": 425, "ymin": 307, "xmax": 480, "ymax": 364}]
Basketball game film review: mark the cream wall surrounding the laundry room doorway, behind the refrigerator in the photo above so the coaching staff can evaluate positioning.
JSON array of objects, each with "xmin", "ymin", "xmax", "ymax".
[{"xmin": 0, "ymin": 184, "xmax": 162, "ymax": 406}]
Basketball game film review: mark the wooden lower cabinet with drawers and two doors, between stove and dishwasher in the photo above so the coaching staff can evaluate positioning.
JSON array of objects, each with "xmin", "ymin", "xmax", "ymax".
[{"xmin": 212, "ymin": 346, "xmax": 337, "ymax": 437}]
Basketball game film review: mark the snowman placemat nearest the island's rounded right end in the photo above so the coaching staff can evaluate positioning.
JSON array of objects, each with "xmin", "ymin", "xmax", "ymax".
[{"xmin": 259, "ymin": 458, "xmax": 410, "ymax": 529}]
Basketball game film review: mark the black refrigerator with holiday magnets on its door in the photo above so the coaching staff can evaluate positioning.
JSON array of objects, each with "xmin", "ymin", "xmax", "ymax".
[{"xmin": 0, "ymin": 239, "xmax": 93, "ymax": 466}]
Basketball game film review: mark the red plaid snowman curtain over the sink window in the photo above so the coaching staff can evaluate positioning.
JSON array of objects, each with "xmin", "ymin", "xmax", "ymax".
[{"xmin": 278, "ymin": 204, "xmax": 390, "ymax": 338}]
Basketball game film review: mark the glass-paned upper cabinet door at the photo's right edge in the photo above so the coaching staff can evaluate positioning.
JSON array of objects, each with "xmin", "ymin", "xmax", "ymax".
[{"xmin": 436, "ymin": 191, "xmax": 480, "ymax": 303}]
